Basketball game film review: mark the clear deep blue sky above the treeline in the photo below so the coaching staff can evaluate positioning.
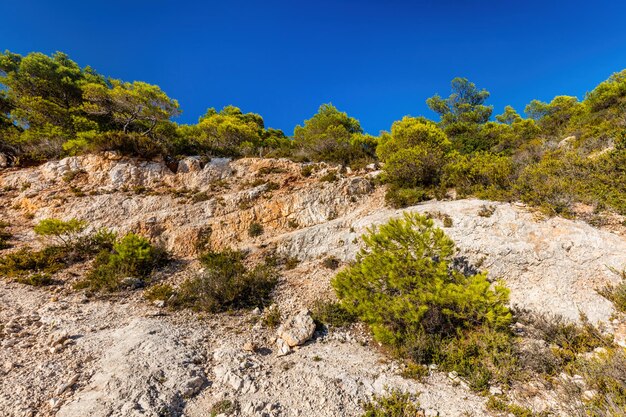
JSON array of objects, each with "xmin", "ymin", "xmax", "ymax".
[{"xmin": 0, "ymin": 0, "xmax": 626, "ymax": 134}]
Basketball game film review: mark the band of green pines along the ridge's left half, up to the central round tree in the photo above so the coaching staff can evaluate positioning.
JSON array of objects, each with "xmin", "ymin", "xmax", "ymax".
[{"xmin": 0, "ymin": 51, "xmax": 292, "ymax": 164}]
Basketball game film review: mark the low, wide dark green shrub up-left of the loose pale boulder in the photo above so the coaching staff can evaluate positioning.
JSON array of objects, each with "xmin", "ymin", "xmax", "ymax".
[{"xmin": 175, "ymin": 250, "xmax": 278, "ymax": 312}]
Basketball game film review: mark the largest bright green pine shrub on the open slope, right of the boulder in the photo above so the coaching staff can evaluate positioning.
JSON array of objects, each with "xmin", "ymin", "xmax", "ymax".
[{"xmin": 332, "ymin": 213, "xmax": 512, "ymax": 389}]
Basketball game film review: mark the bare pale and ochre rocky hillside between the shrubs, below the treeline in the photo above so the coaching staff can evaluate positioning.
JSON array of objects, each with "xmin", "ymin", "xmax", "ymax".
[{"xmin": 0, "ymin": 154, "xmax": 626, "ymax": 417}]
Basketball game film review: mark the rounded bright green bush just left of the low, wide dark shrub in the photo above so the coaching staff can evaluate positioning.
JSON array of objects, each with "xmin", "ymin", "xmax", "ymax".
[{"xmin": 76, "ymin": 233, "xmax": 167, "ymax": 292}]
